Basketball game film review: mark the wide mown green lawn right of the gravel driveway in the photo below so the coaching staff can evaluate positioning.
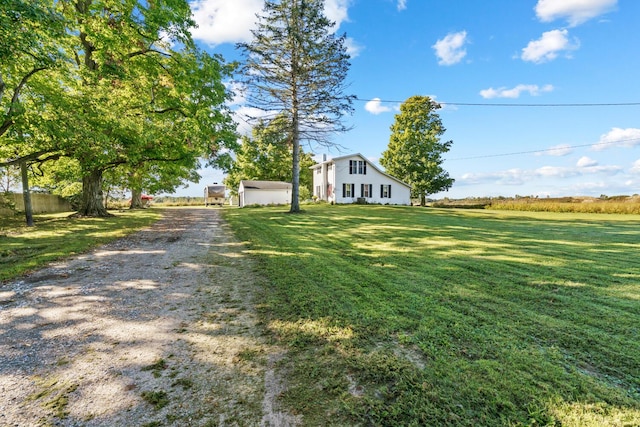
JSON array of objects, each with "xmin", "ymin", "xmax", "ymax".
[{"xmin": 224, "ymin": 205, "xmax": 640, "ymax": 426}]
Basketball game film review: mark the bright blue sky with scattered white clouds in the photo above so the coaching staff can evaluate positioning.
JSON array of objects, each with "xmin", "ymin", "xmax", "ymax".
[{"xmin": 177, "ymin": 0, "xmax": 640, "ymax": 198}]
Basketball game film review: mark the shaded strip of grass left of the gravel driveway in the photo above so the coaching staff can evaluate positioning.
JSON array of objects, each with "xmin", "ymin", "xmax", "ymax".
[{"xmin": 0, "ymin": 209, "xmax": 161, "ymax": 282}]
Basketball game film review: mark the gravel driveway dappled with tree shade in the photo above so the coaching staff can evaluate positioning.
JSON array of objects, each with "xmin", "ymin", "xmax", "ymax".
[{"xmin": 0, "ymin": 208, "xmax": 301, "ymax": 426}]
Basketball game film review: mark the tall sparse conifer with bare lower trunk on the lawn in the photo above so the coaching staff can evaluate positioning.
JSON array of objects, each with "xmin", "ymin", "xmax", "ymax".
[{"xmin": 238, "ymin": 0, "xmax": 355, "ymax": 212}]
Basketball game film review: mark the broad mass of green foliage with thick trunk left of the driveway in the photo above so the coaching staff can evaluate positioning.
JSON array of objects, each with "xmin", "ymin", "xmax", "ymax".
[{"xmin": 0, "ymin": 0, "xmax": 236, "ymax": 215}]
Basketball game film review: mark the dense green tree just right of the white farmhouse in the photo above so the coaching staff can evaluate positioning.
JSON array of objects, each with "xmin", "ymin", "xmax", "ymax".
[{"xmin": 380, "ymin": 96, "xmax": 454, "ymax": 206}]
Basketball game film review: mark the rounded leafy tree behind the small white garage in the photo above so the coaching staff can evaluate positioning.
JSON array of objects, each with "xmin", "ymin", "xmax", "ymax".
[{"xmin": 224, "ymin": 120, "xmax": 315, "ymax": 194}]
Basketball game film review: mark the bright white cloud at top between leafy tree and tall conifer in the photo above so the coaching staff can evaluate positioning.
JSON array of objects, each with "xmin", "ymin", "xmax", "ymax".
[{"xmin": 191, "ymin": 0, "xmax": 264, "ymax": 45}]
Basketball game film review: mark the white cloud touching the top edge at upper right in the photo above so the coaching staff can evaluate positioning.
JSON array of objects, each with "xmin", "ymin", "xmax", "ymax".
[{"xmin": 535, "ymin": 0, "xmax": 618, "ymax": 27}]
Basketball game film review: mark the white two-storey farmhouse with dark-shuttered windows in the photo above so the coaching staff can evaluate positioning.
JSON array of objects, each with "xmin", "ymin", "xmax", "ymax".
[{"xmin": 311, "ymin": 153, "xmax": 411, "ymax": 205}]
